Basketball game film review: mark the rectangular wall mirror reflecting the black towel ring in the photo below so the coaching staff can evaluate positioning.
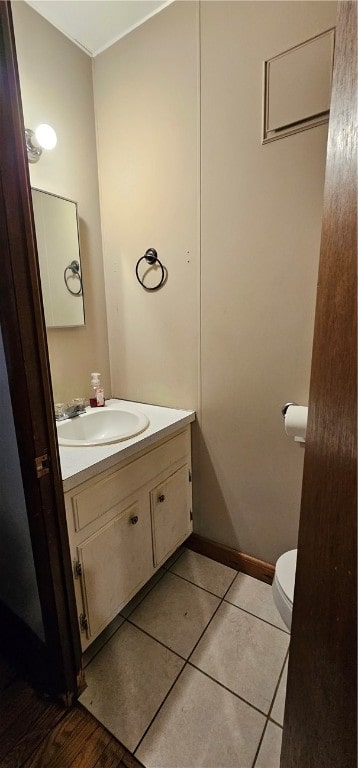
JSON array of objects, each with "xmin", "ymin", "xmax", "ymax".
[{"xmin": 31, "ymin": 188, "xmax": 85, "ymax": 328}]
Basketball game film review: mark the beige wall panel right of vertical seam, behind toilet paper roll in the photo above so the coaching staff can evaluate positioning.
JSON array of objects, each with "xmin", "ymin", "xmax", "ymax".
[{"xmin": 200, "ymin": 2, "xmax": 335, "ymax": 562}]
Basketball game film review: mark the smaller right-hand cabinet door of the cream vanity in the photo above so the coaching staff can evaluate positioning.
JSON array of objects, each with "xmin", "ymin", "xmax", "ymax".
[{"xmin": 150, "ymin": 464, "xmax": 193, "ymax": 566}]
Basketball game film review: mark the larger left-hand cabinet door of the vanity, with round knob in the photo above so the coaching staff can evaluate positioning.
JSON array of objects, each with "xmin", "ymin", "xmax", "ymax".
[{"xmin": 77, "ymin": 502, "xmax": 153, "ymax": 646}]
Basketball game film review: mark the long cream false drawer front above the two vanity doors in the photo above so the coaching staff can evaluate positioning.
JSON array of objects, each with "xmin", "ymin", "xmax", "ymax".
[{"xmin": 72, "ymin": 429, "xmax": 190, "ymax": 531}]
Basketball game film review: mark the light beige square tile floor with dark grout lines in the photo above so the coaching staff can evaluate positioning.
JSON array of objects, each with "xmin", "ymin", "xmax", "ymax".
[{"xmin": 80, "ymin": 548, "xmax": 290, "ymax": 768}]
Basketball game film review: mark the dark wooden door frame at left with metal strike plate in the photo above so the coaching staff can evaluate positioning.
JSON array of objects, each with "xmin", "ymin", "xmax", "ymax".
[{"xmin": 0, "ymin": 2, "xmax": 81, "ymax": 700}]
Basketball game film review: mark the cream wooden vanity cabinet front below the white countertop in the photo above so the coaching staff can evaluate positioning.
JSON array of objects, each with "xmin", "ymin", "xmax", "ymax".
[{"xmin": 65, "ymin": 426, "xmax": 192, "ymax": 650}]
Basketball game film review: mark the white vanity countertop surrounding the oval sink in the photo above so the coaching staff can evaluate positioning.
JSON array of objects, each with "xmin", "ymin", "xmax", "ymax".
[{"xmin": 60, "ymin": 400, "xmax": 195, "ymax": 491}]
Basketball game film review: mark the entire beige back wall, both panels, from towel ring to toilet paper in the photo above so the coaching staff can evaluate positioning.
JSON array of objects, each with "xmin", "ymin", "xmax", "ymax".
[{"xmin": 94, "ymin": 2, "xmax": 335, "ymax": 561}]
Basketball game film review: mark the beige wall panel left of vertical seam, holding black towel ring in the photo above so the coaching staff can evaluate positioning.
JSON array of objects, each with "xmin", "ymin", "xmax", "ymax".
[{"xmin": 94, "ymin": 2, "xmax": 199, "ymax": 408}]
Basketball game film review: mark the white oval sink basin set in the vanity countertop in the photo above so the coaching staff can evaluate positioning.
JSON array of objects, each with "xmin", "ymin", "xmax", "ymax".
[{"xmin": 56, "ymin": 407, "xmax": 149, "ymax": 447}]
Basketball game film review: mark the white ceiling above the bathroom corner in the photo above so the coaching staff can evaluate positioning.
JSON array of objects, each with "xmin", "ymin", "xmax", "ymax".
[{"xmin": 26, "ymin": 0, "xmax": 173, "ymax": 56}]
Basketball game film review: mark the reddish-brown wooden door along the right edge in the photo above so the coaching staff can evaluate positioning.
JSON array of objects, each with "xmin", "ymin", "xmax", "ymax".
[{"xmin": 281, "ymin": 2, "xmax": 357, "ymax": 768}]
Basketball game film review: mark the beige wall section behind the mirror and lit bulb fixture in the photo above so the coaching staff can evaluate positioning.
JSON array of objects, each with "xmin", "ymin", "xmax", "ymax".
[{"xmin": 12, "ymin": 0, "xmax": 110, "ymax": 402}]
